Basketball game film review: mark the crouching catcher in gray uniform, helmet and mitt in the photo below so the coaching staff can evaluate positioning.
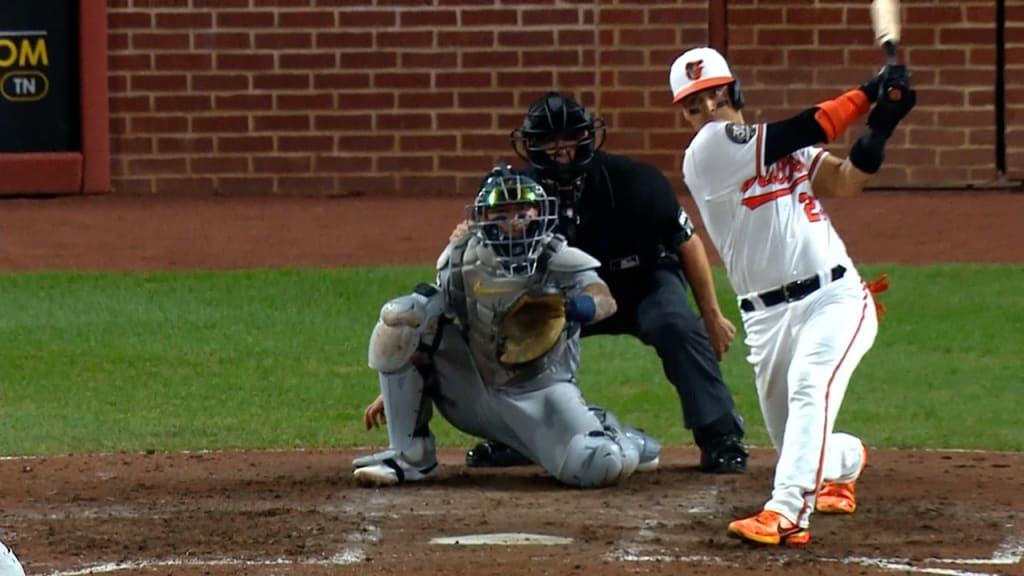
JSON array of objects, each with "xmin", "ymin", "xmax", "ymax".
[{"xmin": 353, "ymin": 166, "xmax": 659, "ymax": 488}]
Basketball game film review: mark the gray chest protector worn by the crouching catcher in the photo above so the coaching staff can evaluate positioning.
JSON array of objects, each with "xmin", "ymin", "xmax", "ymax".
[{"xmin": 447, "ymin": 235, "xmax": 571, "ymax": 387}]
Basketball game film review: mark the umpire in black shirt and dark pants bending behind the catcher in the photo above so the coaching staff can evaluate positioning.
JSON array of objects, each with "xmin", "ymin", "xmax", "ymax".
[{"xmin": 466, "ymin": 92, "xmax": 748, "ymax": 472}]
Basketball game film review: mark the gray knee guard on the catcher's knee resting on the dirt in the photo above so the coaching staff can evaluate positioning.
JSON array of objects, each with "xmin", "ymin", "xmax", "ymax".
[{"xmin": 555, "ymin": 430, "xmax": 637, "ymax": 488}]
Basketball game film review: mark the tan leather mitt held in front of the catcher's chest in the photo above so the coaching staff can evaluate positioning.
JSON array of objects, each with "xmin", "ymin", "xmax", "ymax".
[{"xmin": 498, "ymin": 292, "xmax": 565, "ymax": 365}]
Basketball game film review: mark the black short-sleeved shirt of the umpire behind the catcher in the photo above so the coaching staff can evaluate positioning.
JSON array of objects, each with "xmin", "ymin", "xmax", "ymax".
[{"xmin": 536, "ymin": 147, "xmax": 690, "ymax": 304}]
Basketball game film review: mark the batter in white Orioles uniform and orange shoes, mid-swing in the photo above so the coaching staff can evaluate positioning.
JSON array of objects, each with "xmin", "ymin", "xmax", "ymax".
[{"xmin": 670, "ymin": 47, "xmax": 915, "ymax": 544}]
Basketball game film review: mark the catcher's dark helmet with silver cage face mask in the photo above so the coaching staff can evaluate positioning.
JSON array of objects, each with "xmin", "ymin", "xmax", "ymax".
[{"xmin": 471, "ymin": 164, "xmax": 558, "ymax": 275}]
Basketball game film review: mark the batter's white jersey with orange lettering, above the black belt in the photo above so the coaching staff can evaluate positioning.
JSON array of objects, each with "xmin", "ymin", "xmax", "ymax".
[{"xmin": 683, "ymin": 122, "xmax": 852, "ymax": 297}]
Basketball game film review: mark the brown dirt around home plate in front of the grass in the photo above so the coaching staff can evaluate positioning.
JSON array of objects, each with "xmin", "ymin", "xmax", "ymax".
[{"xmin": 0, "ymin": 448, "xmax": 1024, "ymax": 576}]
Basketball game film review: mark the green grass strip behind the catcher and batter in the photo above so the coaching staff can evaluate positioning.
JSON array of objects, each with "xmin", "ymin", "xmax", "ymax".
[{"xmin": 0, "ymin": 265, "xmax": 1024, "ymax": 455}]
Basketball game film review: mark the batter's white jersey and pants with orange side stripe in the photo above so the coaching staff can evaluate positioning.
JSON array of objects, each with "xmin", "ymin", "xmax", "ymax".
[{"xmin": 683, "ymin": 122, "xmax": 878, "ymax": 528}]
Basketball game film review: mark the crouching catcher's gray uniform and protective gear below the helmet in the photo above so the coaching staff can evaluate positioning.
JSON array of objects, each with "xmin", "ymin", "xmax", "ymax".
[{"xmin": 353, "ymin": 233, "xmax": 658, "ymax": 488}]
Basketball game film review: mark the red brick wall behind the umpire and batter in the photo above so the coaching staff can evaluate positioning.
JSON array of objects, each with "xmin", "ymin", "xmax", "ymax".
[{"xmin": 108, "ymin": 0, "xmax": 1024, "ymax": 195}]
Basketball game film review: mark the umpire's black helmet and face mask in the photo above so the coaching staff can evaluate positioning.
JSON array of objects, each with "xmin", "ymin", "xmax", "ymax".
[{"xmin": 509, "ymin": 92, "xmax": 606, "ymax": 188}]
